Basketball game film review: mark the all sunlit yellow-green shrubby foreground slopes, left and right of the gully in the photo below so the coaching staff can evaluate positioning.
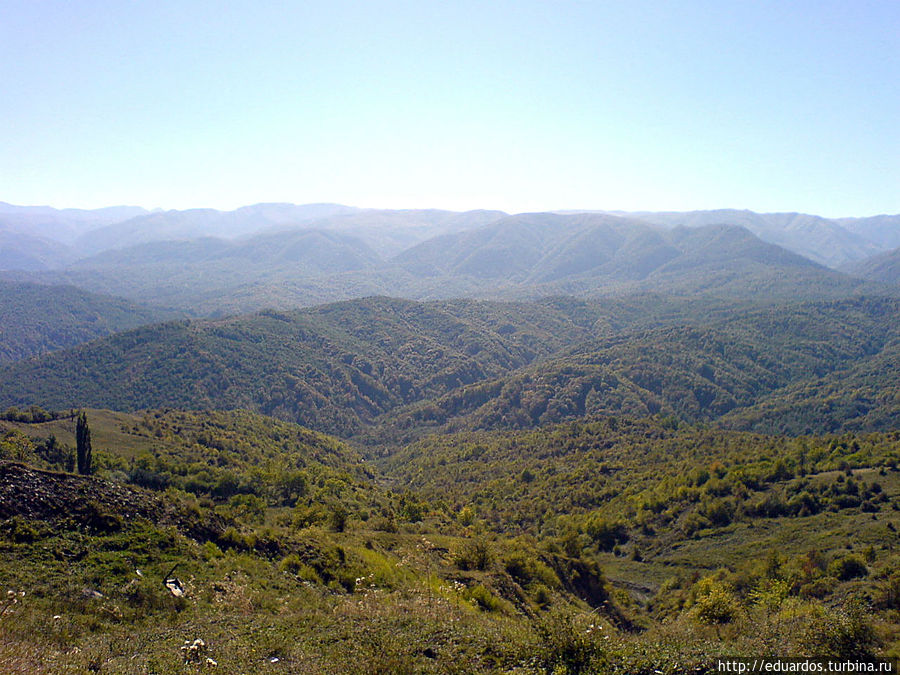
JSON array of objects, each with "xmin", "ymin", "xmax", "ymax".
[{"xmin": 0, "ymin": 410, "xmax": 900, "ymax": 673}]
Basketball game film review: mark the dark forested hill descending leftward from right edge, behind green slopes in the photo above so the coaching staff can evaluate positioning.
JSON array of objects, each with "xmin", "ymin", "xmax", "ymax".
[{"xmin": 379, "ymin": 298, "xmax": 900, "ymax": 441}]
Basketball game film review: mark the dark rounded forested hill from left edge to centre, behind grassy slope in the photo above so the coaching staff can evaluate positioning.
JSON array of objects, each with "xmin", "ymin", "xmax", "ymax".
[{"xmin": 0, "ymin": 298, "xmax": 589, "ymax": 435}]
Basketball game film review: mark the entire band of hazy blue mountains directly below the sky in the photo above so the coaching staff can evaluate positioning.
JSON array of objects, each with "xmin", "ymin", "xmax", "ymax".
[{"xmin": 0, "ymin": 204, "xmax": 900, "ymax": 314}]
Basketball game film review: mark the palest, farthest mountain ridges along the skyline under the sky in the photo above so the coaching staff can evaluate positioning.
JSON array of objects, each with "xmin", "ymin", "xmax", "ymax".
[{"xmin": 0, "ymin": 202, "xmax": 900, "ymax": 268}]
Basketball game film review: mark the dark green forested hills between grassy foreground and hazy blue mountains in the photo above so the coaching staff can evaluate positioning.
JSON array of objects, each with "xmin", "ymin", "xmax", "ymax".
[{"xmin": 0, "ymin": 298, "xmax": 900, "ymax": 441}]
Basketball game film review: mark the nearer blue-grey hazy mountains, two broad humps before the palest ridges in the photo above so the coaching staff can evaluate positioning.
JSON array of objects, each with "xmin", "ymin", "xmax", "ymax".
[{"xmin": 5, "ymin": 213, "xmax": 874, "ymax": 314}]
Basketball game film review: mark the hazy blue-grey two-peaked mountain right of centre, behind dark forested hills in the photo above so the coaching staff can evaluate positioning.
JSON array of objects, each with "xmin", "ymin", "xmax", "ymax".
[{"xmin": 393, "ymin": 213, "xmax": 861, "ymax": 300}]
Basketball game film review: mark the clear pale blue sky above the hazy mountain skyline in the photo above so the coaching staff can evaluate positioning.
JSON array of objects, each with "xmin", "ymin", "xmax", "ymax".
[{"xmin": 0, "ymin": 0, "xmax": 900, "ymax": 217}]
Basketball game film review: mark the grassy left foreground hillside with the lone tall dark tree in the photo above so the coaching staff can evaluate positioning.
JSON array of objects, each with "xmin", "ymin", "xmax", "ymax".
[{"xmin": 0, "ymin": 410, "xmax": 632, "ymax": 673}]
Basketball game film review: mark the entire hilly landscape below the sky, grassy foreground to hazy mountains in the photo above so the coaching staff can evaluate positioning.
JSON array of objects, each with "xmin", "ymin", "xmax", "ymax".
[{"xmin": 0, "ymin": 204, "xmax": 900, "ymax": 675}]
